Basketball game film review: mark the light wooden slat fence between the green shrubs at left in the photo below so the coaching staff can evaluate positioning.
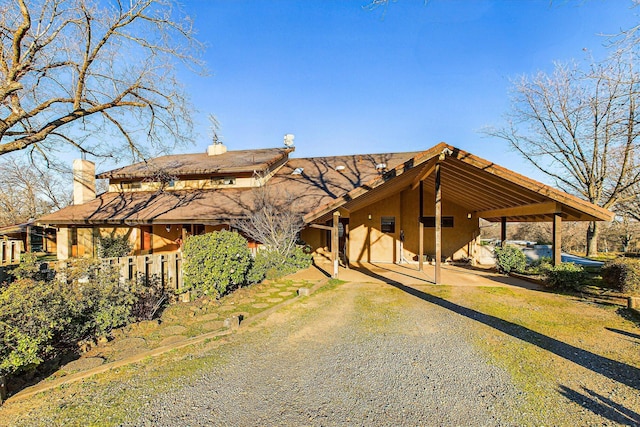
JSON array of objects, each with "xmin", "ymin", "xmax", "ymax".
[{"xmin": 102, "ymin": 253, "xmax": 182, "ymax": 290}]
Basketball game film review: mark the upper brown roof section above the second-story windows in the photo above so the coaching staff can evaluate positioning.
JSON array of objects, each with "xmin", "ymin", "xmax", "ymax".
[{"xmin": 97, "ymin": 148, "xmax": 293, "ymax": 179}]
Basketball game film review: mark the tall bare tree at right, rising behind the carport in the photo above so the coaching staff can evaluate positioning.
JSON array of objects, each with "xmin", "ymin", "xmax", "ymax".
[{"xmin": 485, "ymin": 50, "xmax": 640, "ymax": 255}]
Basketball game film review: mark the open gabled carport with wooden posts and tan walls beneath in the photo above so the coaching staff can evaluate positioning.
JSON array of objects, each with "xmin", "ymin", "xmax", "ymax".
[{"xmin": 305, "ymin": 143, "xmax": 613, "ymax": 283}]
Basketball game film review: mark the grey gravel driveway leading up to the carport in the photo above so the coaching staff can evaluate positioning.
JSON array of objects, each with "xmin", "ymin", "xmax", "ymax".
[{"xmin": 131, "ymin": 283, "xmax": 525, "ymax": 426}]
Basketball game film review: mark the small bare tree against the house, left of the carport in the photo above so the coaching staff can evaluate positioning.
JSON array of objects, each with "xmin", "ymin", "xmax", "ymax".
[{"xmin": 232, "ymin": 180, "xmax": 304, "ymax": 260}]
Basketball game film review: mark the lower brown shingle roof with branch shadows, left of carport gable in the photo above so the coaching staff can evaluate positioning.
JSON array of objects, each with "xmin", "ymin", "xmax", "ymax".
[{"xmin": 38, "ymin": 153, "xmax": 415, "ymax": 224}]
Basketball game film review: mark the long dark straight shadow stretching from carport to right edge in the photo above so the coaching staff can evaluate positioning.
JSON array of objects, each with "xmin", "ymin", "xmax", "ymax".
[{"xmin": 360, "ymin": 268, "xmax": 640, "ymax": 390}]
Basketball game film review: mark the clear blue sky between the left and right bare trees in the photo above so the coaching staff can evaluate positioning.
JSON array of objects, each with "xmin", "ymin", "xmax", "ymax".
[{"xmin": 174, "ymin": 0, "xmax": 640, "ymax": 181}]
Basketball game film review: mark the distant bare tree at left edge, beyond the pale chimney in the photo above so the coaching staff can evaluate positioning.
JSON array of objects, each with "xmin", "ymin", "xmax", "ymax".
[{"xmin": 0, "ymin": 159, "xmax": 71, "ymax": 226}]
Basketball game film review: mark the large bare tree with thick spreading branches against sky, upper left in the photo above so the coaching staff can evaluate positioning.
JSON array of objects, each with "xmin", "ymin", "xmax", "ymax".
[{"xmin": 0, "ymin": 0, "xmax": 202, "ymax": 164}]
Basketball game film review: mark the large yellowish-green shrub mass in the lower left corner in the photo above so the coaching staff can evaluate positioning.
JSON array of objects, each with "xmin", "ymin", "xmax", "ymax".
[{"xmin": 0, "ymin": 260, "xmax": 138, "ymax": 375}]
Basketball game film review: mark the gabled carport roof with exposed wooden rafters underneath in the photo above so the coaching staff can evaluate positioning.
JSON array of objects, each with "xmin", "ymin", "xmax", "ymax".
[{"xmin": 304, "ymin": 143, "xmax": 613, "ymax": 223}]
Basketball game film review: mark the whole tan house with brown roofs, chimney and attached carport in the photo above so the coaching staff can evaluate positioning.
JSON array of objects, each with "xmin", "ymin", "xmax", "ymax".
[{"xmin": 39, "ymin": 143, "xmax": 612, "ymax": 282}]
